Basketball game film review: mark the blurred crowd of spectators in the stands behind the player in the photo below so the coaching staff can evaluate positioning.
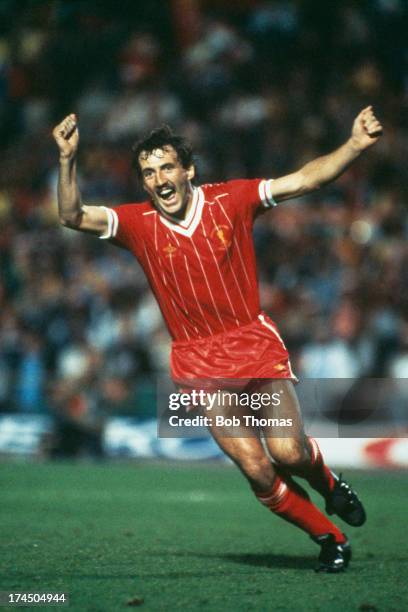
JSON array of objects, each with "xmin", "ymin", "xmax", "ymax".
[{"xmin": 0, "ymin": 0, "xmax": 408, "ymax": 431}]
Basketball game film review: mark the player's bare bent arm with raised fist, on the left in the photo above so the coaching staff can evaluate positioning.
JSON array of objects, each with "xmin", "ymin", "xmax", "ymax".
[{"xmin": 53, "ymin": 114, "xmax": 108, "ymax": 236}]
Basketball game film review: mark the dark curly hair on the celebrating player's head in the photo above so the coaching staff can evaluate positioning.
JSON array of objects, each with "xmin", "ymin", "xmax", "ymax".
[{"xmin": 132, "ymin": 125, "xmax": 194, "ymax": 179}]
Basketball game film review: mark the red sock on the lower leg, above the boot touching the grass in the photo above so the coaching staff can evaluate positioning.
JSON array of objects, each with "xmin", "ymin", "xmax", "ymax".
[{"xmin": 256, "ymin": 475, "xmax": 346, "ymax": 544}]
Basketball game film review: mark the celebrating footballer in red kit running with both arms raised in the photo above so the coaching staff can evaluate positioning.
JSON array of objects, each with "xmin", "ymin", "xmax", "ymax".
[{"xmin": 53, "ymin": 106, "xmax": 382, "ymax": 573}]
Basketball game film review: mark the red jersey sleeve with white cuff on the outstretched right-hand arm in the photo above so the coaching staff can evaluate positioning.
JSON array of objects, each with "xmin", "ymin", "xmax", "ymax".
[{"xmin": 223, "ymin": 179, "xmax": 276, "ymax": 216}]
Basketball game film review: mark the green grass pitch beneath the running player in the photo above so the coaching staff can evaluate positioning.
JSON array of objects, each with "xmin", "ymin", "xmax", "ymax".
[{"xmin": 0, "ymin": 462, "xmax": 408, "ymax": 612}]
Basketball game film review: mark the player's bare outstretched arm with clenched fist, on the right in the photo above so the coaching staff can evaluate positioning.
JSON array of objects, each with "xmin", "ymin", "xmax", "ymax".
[{"xmin": 271, "ymin": 106, "xmax": 382, "ymax": 202}]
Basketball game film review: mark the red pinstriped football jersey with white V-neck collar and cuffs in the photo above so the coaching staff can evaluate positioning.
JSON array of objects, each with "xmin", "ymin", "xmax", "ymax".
[{"xmin": 103, "ymin": 179, "xmax": 275, "ymax": 340}]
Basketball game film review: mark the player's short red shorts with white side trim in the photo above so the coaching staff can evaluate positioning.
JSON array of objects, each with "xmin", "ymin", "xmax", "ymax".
[{"xmin": 170, "ymin": 313, "xmax": 297, "ymax": 391}]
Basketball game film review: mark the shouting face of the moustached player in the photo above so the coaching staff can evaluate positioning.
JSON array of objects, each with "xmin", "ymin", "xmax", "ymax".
[{"xmin": 139, "ymin": 145, "xmax": 194, "ymax": 218}]
